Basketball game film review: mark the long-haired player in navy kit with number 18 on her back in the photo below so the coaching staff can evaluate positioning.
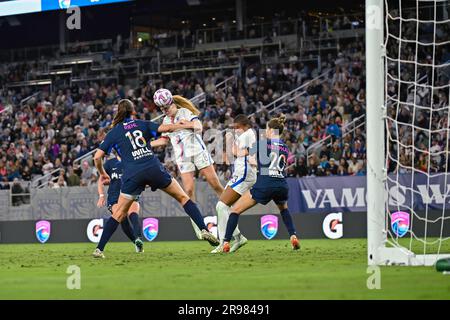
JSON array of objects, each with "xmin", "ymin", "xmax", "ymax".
[{"xmin": 93, "ymin": 99, "xmax": 219, "ymax": 258}]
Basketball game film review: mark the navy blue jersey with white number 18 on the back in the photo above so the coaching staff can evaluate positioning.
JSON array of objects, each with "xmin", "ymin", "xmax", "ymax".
[{"xmin": 99, "ymin": 119, "xmax": 160, "ymax": 179}]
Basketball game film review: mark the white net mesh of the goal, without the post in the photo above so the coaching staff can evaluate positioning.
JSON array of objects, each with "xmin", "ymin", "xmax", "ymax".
[{"xmin": 380, "ymin": 0, "xmax": 450, "ymax": 260}]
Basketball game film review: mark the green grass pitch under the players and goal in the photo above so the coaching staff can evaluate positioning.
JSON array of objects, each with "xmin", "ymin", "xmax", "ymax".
[{"xmin": 0, "ymin": 239, "xmax": 450, "ymax": 299}]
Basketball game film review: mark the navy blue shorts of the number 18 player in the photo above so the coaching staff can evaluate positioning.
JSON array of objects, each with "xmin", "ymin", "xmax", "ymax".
[{"xmin": 121, "ymin": 164, "xmax": 172, "ymax": 196}]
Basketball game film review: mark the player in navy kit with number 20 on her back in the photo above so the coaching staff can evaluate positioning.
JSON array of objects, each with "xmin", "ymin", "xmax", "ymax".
[{"xmin": 221, "ymin": 115, "xmax": 300, "ymax": 253}]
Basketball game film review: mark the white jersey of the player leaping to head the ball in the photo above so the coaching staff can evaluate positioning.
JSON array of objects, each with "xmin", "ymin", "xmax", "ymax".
[{"xmin": 161, "ymin": 108, "xmax": 206, "ymax": 164}]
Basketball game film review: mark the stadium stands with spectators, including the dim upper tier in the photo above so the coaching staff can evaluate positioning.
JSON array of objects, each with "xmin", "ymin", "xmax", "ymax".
[{"xmin": 0, "ymin": 10, "xmax": 449, "ymax": 192}]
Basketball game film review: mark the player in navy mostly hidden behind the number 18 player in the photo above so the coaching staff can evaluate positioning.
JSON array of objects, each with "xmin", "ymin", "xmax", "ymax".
[{"xmin": 97, "ymin": 154, "xmax": 144, "ymax": 253}]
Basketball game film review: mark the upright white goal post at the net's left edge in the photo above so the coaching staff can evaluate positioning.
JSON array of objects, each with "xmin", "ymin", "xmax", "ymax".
[{"xmin": 366, "ymin": 0, "xmax": 386, "ymax": 265}]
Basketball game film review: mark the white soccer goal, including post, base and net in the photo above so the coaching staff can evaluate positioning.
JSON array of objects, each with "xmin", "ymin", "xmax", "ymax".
[{"xmin": 366, "ymin": 0, "xmax": 450, "ymax": 265}]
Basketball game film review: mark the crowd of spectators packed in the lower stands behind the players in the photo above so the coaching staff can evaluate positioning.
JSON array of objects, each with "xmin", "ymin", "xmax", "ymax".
[{"xmin": 0, "ymin": 6, "xmax": 448, "ymax": 188}]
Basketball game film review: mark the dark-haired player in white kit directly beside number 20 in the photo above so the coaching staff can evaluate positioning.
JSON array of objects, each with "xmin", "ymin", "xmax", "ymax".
[{"xmin": 211, "ymin": 114, "xmax": 256, "ymax": 253}]
